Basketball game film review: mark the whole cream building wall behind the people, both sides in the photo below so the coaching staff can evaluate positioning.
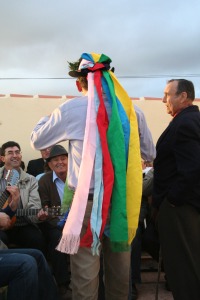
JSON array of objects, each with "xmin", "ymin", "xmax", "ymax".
[{"xmin": 0, "ymin": 95, "xmax": 200, "ymax": 166}]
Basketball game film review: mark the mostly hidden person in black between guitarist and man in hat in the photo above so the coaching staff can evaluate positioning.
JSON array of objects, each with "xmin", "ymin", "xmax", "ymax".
[{"xmin": 27, "ymin": 147, "xmax": 51, "ymax": 177}]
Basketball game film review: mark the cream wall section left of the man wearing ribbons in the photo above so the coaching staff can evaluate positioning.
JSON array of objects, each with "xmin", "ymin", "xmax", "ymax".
[{"xmin": 0, "ymin": 97, "xmax": 67, "ymax": 167}]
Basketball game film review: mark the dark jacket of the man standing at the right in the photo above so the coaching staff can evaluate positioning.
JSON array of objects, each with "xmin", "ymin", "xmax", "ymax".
[{"xmin": 153, "ymin": 105, "xmax": 200, "ymax": 209}]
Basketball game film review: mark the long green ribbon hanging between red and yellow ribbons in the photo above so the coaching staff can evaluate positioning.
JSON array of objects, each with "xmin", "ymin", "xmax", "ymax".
[{"xmin": 103, "ymin": 71, "xmax": 129, "ymax": 251}]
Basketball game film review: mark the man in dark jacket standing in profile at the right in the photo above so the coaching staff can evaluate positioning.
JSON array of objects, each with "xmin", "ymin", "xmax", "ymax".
[{"xmin": 153, "ymin": 79, "xmax": 200, "ymax": 300}]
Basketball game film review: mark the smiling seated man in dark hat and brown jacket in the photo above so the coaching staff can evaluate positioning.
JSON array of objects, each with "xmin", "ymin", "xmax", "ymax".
[{"xmin": 38, "ymin": 145, "xmax": 70, "ymax": 294}]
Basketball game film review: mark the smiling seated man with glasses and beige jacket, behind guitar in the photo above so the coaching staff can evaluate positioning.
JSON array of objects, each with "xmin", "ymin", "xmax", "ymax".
[{"xmin": 0, "ymin": 141, "xmax": 46, "ymax": 253}]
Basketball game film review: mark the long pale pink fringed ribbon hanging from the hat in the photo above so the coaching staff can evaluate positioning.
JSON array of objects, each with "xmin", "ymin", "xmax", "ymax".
[{"xmin": 56, "ymin": 73, "xmax": 96, "ymax": 254}]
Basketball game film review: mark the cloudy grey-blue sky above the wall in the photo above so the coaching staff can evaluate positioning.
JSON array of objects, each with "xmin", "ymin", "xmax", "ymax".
[{"xmin": 0, "ymin": 0, "xmax": 200, "ymax": 98}]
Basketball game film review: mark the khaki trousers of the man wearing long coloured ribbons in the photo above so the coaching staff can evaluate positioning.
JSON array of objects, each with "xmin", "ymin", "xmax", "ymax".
[{"xmin": 70, "ymin": 201, "xmax": 130, "ymax": 300}]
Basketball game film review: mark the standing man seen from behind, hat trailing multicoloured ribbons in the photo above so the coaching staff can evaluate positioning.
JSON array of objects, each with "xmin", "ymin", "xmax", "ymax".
[{"xmin": 31, "ymin": 53, "xmax": 151, "ymax": 300}]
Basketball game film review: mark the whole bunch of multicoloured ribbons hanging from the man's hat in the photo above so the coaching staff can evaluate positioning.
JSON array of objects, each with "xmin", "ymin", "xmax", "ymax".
[{"xmin": 57, "ymin": 53, "xmax": 142, "ymax": 254}]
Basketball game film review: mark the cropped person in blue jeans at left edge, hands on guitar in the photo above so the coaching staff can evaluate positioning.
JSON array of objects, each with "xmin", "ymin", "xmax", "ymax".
[{"xmin": 0, "ymin": 175, "xmax": 58, "ymax": 300}]
